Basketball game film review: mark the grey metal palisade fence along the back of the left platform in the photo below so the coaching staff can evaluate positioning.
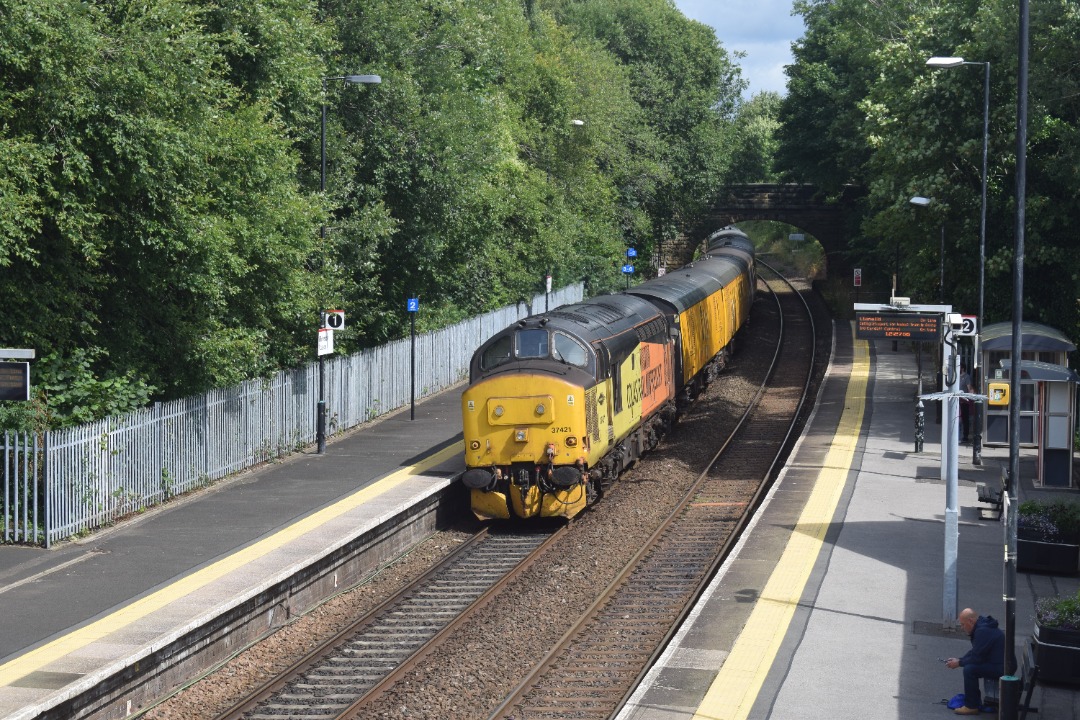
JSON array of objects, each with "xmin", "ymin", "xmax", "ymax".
[{"xmin": 0, "ymin": 283, "xmax": 583, "ymax": 547}]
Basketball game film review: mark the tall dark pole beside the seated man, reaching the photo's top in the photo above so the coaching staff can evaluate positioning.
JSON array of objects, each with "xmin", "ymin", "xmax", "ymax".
[{"xmin": 998, "ymin": 0, "xmax": 1028, "ymax": 720}]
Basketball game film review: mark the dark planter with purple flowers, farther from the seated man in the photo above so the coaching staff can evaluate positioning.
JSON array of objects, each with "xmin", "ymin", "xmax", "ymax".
[{"xmin": 1016, "ymin": 500, "xmax": 1080, "ymax": 575}]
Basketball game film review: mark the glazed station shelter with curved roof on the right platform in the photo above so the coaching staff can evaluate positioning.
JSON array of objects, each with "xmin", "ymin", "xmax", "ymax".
[{"xmin": 980, "ymin": 322, "xmax": 1080, "ymax": 487}]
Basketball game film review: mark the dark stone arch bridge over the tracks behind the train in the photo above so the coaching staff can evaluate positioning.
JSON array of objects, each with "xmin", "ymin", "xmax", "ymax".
[{"xmin": 664, "ymin": 182, "xmax": 862, "ymax": 274}]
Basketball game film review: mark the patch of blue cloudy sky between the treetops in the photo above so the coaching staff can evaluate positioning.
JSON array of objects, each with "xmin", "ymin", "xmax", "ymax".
[{"xmin": 675, "ymin": 0, "xmax": 802, "ymax": 98}]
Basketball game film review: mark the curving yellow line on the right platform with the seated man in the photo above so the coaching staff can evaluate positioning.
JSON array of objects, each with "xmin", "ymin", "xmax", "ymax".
[{"xmin": 693, "ymin": 328, "xmax": 869, "ymax": 720}]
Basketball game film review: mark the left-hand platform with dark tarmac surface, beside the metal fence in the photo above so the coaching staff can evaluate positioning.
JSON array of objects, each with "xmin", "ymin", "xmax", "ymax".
[{"xmin": 0, "ymin": 386, "xmax": 468, "ymax": 720}]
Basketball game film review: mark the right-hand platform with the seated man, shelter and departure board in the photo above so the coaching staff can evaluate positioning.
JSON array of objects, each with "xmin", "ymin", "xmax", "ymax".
[{"xmin": 619, "ymin": 323, "xmax": 1080, "ymax": 720}]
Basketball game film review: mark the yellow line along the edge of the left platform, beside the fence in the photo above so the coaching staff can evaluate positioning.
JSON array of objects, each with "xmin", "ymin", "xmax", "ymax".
[{"xmin": 0, "ymin": 443, "xmax": 464, "ymax": 685}]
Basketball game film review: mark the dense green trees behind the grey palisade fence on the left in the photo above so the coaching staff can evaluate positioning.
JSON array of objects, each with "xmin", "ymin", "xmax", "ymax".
[{"xmin": 0, "ymin": 0, "xmax": 751, "ymax": 427}]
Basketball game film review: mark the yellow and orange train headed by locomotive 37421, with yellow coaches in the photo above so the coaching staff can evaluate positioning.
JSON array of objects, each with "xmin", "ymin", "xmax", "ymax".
[{"xmin": 461, "ymin": 228, "xmax": 756, "ymax": 519}]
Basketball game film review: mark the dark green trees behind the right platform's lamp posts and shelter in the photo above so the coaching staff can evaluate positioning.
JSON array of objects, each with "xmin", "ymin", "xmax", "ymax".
[{"xmin": 778, "ymin": 0, "xmax": 1080, "ymax": 354}]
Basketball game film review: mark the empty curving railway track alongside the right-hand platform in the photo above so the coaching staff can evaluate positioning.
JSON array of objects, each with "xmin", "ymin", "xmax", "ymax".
[{"xmin": 489, "ymin": 263, "xmax": 815, "ymax": 720}]
